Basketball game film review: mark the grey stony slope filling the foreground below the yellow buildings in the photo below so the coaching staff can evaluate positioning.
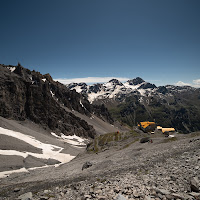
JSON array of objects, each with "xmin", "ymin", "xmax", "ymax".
[{"xmin": 0, "ymin": 129, "xmax": 200, "ymax": 200}]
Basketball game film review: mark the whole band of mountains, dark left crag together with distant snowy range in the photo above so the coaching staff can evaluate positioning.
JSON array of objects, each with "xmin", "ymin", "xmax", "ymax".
[{"xmin": 0, "ymin": 64, "xmax": 200, "ymax": 135}]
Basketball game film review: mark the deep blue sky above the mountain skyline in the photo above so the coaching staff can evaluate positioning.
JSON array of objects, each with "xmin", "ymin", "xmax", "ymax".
[{"xmin": 0, "ymin": 0, "xmax": 200, "ymax": 86}]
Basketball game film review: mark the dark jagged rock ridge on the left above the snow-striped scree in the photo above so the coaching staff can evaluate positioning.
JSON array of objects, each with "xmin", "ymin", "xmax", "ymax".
[{"xmin": 0, "ymin": 64, "xmax": 113, "ymax": 138}]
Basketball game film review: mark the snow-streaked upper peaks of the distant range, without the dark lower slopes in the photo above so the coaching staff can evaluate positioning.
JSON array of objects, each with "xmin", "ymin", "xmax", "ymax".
[{"xmin": 67, "ymin": 77, "xmax": 195, "ymax": 103}]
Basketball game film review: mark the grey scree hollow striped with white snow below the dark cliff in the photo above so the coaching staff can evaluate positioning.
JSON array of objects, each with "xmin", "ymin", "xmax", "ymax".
[{"xmin": 0, "ymin": 117, "xmax": 85, "ymax": 176}]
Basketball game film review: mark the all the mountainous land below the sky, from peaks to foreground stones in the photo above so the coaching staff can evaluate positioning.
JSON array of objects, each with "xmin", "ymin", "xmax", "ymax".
[{"xmin": 0, "ymin": 64, "xmax": 200, "ymax": 200}]
